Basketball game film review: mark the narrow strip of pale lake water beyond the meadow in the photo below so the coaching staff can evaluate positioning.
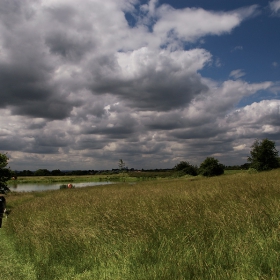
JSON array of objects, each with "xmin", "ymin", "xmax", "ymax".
[{"xmin": 8, "ymin": 182, "xmax": 112, "ymax": 192}]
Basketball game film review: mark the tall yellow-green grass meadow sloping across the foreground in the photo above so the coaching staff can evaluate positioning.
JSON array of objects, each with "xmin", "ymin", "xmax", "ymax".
[{"xmin": 0, "ymin": 169, "xmax": 280, "ymax": 280}]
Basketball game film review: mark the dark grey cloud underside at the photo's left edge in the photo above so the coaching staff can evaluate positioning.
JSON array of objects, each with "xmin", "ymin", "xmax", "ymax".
[{"xmin": 0, "ymin": 39, "xmax": 73, "ymax": 119}]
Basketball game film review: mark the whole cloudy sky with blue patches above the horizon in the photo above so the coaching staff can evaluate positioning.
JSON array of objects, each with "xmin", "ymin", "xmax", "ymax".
[{"xmin": 0, "ymin": 0, "xmax": 280, "ymax": 170}]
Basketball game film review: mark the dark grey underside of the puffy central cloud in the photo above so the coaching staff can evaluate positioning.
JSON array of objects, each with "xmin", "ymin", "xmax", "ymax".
[{"xmin": 94, "ymin": 72, "xmax": 208, "ymax": 111}]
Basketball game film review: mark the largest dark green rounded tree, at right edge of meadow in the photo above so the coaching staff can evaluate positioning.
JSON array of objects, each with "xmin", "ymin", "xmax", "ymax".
[{"xmin": 248, "ymin": 138, "xmax": 279, "ymax": 171}]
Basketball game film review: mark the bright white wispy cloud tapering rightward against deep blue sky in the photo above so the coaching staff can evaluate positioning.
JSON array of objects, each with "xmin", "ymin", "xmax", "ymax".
[{"xmin": 153, "ymin": 5, "xmax": 257, "ymax": 44}]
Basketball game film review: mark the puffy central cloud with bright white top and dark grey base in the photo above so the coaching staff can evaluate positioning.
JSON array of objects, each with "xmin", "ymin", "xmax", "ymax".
[{"xmin": 90, "ymin": 48, "xmax": 210, "ymax": 111}]
